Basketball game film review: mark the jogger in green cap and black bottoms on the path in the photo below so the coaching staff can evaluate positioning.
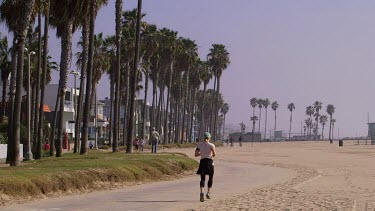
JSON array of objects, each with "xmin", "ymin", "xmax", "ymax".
[{"xmin": 195, "ymin": 132, "xmax": 216, "ymax": 202}]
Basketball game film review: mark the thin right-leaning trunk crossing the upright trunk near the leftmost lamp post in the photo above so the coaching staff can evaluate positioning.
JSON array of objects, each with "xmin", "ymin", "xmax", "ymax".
[{"xmin": 38, "ymin": 0, "xmax": 49, "ymax": 158}]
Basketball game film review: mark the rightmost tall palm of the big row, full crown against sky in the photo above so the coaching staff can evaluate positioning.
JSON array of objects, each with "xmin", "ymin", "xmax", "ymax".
[{"xmin": 207, "ymin": 44, "xmax": 230, "ymax": 140}]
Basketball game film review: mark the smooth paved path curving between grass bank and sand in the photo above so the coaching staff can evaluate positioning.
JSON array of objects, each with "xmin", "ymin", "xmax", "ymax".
[{"xmin": 0, "ymin": 153, "xmax": 294, "ymax": 211}]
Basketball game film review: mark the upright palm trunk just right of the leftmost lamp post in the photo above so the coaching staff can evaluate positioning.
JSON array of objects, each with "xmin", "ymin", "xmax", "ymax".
[{"xmin": 34, "ymin": 11, "xmax": 43, "ymax": 159}]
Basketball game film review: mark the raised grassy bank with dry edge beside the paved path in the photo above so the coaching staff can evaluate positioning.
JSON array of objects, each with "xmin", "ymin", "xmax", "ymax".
[{"xmin": 0, "ymin": 151, "xmax": 198, "ymax": 203}]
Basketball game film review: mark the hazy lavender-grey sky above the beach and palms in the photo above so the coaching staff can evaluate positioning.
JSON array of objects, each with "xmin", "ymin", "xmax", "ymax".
[{"xmin": 1, "ymin": 0, "xmax": 375, "ymax": 137}]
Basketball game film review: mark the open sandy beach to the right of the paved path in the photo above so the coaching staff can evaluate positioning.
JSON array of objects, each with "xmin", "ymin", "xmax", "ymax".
[{"xmin": 191, "ymin": 141, "xmax": 375, "ymax": 210}]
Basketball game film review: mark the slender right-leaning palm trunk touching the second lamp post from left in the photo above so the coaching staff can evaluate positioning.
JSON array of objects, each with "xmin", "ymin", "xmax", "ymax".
[{"xmin": 74, "ymin": 17, "xmax": 89, "ymax": 153}]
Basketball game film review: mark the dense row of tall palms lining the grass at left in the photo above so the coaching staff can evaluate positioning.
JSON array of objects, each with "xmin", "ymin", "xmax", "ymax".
[{"xmin": 0, "ymin": 0, "xmax": 230, "ymax": 166}]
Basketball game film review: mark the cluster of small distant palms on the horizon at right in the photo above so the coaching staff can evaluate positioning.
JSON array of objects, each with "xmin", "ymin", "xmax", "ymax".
[{"xmin": 250, "ymin": 97, "xmax": 336, "ymax": 140}]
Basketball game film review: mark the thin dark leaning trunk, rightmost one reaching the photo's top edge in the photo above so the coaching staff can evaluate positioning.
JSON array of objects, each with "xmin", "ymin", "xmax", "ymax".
[{"xmin": 126, "ymin": 0, "xmax": 142, "ymax": 153}]
